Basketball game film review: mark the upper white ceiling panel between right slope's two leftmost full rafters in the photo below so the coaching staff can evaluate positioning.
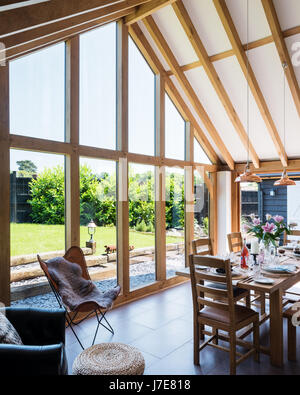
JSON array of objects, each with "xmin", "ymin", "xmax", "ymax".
[{"xmin": 152, "ymin": 6, "xmax": 198, "ymax": 66}]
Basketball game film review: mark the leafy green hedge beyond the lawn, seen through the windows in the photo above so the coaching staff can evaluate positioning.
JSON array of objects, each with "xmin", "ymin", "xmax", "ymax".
[{"xmin": 29, "ymin": 165, "xmax": 188, "ymax": 231}]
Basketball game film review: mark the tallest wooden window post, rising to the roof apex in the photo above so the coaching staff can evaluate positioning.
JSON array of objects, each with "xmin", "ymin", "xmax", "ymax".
[{"xmin": 117, "ymin": 20, "xmax": 130, "ymax": 296}]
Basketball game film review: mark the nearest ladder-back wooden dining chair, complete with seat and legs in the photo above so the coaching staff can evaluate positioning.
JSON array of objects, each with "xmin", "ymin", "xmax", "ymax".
[{"xmin": 189, "ymin": 255, "xmax": 259, "ymax": 374}]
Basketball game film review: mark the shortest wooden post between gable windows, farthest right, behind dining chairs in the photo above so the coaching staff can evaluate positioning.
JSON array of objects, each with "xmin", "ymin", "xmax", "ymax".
[{"xmin": 184, "ymin": 122, "xmax": 194, "ymax": 266}]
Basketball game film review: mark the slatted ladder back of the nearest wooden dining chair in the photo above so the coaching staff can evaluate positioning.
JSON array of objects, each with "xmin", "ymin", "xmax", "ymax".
[{"xmin": 189, "ymin": 255, "xmax": 234, "ymax": 322}]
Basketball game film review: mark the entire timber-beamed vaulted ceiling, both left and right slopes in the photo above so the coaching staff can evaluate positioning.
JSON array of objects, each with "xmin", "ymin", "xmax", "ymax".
[{"xmin": 0, "ymin": 0, "xmax": 300, "ymax": 169}]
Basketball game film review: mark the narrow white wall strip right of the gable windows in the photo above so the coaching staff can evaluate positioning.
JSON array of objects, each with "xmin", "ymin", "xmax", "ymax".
[{"xmin": 217, "ymin": 171, "xmax": 231, "ymax": 254}]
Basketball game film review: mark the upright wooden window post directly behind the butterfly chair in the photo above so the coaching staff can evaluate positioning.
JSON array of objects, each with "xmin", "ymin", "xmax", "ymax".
[{"xmin": 65, "ymin": 36, "xmax": 80, "ymax": 248}]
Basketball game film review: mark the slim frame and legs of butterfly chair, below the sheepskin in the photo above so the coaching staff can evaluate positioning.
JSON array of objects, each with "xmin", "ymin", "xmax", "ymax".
[{"xmin": 47, "ymin": 270, "xmax": 114, "ymax": 350}]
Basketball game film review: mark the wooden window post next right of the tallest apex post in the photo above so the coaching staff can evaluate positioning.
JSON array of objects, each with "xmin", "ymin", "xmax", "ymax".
[{"xmin": 155, "ymin": 74, "xmax": 166, "ymax": 281}]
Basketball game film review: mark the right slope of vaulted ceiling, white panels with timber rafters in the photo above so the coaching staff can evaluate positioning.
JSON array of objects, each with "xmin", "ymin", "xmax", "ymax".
[{"xmin": 129, "ymin": 0, "xmax": 300, "ymax": 167}]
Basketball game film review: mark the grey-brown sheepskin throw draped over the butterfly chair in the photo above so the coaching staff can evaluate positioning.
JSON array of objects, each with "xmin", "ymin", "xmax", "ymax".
[{"xmin": 46, "ymin": 258, "xmax": 121, "ymax": 311}]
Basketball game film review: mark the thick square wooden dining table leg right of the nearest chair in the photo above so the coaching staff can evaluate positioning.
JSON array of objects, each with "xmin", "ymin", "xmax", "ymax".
[{"xmin": 270, "ymin": 289, "xmax": 283, "ymax": 367}]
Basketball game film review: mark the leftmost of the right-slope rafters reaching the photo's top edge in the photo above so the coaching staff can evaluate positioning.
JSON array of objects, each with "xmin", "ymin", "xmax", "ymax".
[{"xmin": 172, "ymin": 0, "xmax": 259, "ymax": 167}]
